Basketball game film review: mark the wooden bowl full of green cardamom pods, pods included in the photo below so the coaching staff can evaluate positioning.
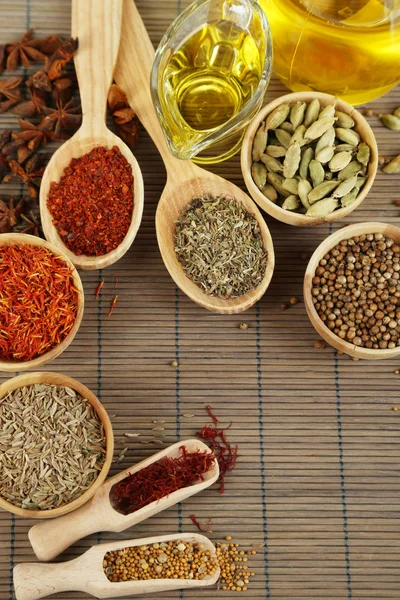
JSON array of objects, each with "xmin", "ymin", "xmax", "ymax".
[{"xmin": 241, "ymin": 92, "xmax": 378, "ymax": 227}]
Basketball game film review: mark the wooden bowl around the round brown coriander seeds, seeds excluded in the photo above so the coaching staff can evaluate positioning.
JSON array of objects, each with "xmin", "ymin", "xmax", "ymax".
[{"xmin": 304, "ymin": 222, "xmax": 400, "ymax": 360}]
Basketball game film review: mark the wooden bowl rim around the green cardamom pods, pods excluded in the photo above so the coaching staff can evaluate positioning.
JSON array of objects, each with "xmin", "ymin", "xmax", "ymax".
[{"xmin": 241, "ymin": 92, "xmax": 378, "ymax": 227}]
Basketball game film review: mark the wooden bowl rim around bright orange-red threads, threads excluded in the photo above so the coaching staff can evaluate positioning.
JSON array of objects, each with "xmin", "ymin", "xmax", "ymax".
[{"xmin": 0, "ymin": 233, "xmax": 85, "ymax": 372}]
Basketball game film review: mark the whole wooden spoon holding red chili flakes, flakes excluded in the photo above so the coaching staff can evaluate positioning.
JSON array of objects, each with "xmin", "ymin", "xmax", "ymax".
[{"xmin": 40, "ymin": 0, "xmax": 144, "ymax": 269}]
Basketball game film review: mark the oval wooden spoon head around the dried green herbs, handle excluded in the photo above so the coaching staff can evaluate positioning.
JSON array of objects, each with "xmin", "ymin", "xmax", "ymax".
[{"xmin": 156, "ymin": 177, "xmax": 275, "ymax": 314}]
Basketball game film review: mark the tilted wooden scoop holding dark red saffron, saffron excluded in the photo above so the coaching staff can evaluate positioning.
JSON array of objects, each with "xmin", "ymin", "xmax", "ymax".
[{"xmin": 28, "ymin": 440, "xmax": 219, "ymax": 561}]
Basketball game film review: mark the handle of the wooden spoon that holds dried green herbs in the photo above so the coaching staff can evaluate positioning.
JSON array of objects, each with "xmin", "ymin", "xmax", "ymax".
[{"xmin": 115, "ymin": 0, "xmax": 195, "ymax": 179}]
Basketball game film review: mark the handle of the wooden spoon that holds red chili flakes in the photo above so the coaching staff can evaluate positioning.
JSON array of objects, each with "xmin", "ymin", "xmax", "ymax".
[{"xmin": 72, "ymin": 0, "xmax": 122, "ymax": 132}]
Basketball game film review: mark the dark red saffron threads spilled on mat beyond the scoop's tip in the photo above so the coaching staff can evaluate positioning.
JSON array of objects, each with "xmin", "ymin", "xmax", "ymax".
[{"xmin": 197, "ymin": 405, "xmax": 238, "ymax": 494}]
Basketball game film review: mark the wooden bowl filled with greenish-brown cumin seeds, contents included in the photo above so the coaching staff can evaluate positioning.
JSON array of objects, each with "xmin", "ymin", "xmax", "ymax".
[{"xmin": 0, "ymin": 373, "xmax": 114, "ymax": 519}]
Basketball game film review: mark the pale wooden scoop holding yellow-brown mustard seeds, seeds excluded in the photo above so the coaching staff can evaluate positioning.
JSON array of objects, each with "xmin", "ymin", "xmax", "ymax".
[{"xmin": 14, "ymin": 533, "xmax": 220, "ymax": 600}]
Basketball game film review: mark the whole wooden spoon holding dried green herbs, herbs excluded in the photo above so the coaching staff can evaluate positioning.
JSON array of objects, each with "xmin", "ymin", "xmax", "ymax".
[{"xmin": 114, "ymin": 0, "xmax": 274, "ymax": 314}]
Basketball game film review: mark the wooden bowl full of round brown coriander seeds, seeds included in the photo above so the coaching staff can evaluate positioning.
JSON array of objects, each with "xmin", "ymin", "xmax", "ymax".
[{"xmin": 304, "ymin": 222, "xmax": 400, "ymax": 360}]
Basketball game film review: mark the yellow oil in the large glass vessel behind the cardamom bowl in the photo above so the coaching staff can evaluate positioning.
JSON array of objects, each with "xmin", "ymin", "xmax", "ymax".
[{"xmin": 259, "ymin": 0, "xmax": 400, "ymax": 104}]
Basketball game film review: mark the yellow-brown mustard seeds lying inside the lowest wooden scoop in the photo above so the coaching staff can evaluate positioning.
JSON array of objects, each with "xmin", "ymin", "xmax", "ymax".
[{"xmin": 103, "ymin": 540, "xmax": 218, "ymax": 582}]
